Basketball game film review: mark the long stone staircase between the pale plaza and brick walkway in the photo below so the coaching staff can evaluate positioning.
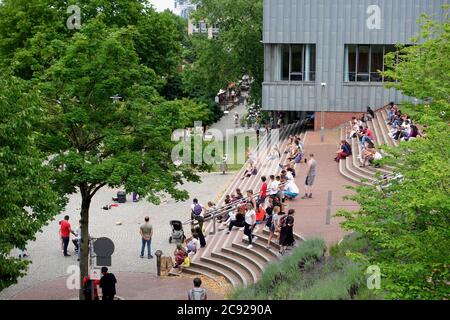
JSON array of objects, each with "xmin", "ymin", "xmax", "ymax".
[{"xmin": 170, "ymin": 121, "xmax": 305, "ymax": 287}]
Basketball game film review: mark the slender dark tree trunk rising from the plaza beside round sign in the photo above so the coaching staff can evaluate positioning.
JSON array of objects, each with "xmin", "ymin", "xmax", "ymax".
[{"xmin": 79, "ymin": 188, "xmax": 91, "ymax": 300}]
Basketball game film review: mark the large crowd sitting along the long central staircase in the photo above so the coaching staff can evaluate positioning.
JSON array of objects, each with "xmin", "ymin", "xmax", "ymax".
[{"xmin": 178, "ymin": 135, "xmax": 304, "ymax": 262}]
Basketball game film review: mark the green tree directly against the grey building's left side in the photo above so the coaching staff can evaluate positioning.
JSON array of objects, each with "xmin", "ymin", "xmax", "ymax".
[{"xmin": 188, "ymin": 0, "xmax": 264, "ymax": 105}]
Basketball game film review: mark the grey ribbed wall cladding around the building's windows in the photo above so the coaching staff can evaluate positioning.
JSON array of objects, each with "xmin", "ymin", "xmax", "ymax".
[{"xmin": 262, "ymin": 0, "xmax": 450, "ymax": 112}]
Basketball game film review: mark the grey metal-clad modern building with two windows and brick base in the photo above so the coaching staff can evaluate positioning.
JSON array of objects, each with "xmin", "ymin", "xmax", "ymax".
[{"xmin": 262, "ymin": 0, "xmax": 449, "ymax": 129}]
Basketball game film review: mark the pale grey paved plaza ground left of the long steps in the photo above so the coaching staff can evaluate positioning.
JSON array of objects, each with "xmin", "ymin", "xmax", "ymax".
[{"xmin": 0, "ymin": 173, "xmax": 233, "ymax": 299}]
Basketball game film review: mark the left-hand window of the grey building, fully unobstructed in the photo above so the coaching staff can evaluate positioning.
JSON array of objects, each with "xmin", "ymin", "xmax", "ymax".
[{"xmin": 278, "ymin": 44, "xmax": 316, "ymax": 81}]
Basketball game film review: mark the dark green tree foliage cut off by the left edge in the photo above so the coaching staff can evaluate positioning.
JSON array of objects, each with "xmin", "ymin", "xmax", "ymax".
[{"xmin": 0, "ymin": 75, "xmax": 63, "ymax": 290}]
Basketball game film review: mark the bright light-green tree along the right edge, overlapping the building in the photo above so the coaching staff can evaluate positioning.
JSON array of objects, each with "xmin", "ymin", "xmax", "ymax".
[{"xmin": 338, "ymin": 13, "xmax": 450, "ymax": 299}]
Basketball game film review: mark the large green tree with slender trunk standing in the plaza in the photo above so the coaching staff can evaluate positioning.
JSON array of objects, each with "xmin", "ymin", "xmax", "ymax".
[{"xmin": 40, "ymin": 16, "xmax": 199, "ymax": 298}]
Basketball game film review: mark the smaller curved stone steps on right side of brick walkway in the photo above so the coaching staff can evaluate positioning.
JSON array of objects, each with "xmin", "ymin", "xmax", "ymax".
[{"xmin": 339, "ymin": 108, "xmax": 398, "ymax": 185}]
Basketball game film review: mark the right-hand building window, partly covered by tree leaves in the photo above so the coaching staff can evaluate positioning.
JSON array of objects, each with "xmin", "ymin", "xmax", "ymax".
[{"xmin": 344, "ymin": 44, "xmax": 397, "ymax": 82}]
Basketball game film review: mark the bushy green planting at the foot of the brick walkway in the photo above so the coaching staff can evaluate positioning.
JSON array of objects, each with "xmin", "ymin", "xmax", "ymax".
[{"xmin": 228, "ymin": 234, "xmax": 382, "ymax": 300}]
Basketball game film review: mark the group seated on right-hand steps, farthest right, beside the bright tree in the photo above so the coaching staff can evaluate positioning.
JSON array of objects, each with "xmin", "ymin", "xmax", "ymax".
[{"xmin": 386, "ymin": 102, "xmax": 423, "ymax": 141}]
